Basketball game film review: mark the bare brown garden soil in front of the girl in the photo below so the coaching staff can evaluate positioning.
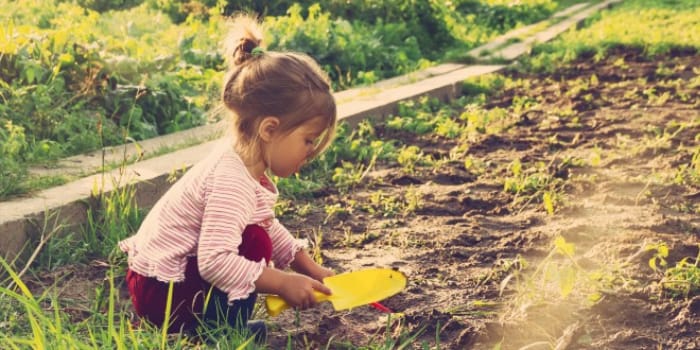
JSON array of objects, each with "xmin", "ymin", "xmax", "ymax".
[{"xmin": 23, "ymin": 49, "xmax": 700, "ymax": 349}]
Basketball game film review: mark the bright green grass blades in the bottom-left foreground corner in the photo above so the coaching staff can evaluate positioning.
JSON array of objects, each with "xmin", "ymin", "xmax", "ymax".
[{"xmin": 0, "ymin": 258, "xmax": 259, "ymax": 350}]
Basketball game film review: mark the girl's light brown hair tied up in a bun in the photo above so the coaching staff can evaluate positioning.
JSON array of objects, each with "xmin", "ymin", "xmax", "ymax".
[{"xmin": 222, "ymin": 15, "xmax": 336, "ymax": 163}]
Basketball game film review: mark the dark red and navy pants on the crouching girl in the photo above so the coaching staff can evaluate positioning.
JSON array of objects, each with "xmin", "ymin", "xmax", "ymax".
[{"xmin": 126, "ymin": 225, "xmax": 272, "ymax": 333}]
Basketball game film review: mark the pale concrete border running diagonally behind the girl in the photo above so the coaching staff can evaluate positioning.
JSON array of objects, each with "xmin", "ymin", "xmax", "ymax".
[{"xmin": 0, "ymin": 0, "xmax": 622, "ymax": 260}]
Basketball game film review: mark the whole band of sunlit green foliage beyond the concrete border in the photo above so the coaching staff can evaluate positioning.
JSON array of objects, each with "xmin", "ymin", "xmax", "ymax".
[{"xmin": 0, "ymin": 0, "xmax": 556, "ymax": 197}]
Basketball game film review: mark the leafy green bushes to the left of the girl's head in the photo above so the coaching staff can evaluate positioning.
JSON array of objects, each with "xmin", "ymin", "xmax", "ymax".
[{"xmin": 0, "ymin": 0, "xmax": 209, "ymax": 172}]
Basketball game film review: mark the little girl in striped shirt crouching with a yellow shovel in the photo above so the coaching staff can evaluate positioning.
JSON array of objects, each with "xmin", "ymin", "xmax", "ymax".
[{"xmin": 119, "ymin": 16, "xmax": 336, "ymax": 342}]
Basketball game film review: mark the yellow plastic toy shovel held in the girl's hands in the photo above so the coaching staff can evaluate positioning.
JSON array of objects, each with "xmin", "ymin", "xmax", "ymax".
[{"xmin": 265, "ymin": 269, "xmax": 406, "ymax": 316}]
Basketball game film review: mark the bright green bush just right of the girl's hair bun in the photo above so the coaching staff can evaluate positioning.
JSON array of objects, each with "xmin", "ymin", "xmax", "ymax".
[{"xmin": 266, "ymin": 5, "xmax": 422, "ymax": 88}]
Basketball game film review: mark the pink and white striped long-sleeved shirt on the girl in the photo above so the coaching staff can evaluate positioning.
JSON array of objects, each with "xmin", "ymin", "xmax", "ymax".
[{"xmin": 119, "ymin": 140, "xmax": 303, "ymax": 302}]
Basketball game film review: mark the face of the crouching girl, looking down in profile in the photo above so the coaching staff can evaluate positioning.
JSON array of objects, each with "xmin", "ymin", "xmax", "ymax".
[{"xmin": 268, "ymin": 118, "xmax": 324, "ymax": 177}]
